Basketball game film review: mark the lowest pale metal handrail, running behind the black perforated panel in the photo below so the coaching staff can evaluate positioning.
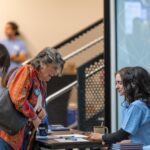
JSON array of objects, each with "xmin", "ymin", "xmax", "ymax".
[{"xmin": 46, "ymin": 65, "xmax": 104, "ymax": 103}]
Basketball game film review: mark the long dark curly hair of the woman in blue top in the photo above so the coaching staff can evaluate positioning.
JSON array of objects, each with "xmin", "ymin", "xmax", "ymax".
[{"xmin": 117, "ymin": 66, "xmax": 150, "ymax": 106}]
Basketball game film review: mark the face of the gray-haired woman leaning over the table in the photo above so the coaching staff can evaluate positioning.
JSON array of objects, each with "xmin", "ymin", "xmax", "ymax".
[{"xmin": 39, "ymin": 63, "xmax": 59, "ymax": 81}]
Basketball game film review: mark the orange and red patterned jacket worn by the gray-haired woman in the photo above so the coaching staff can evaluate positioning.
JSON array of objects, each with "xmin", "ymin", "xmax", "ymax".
[{"xmin": 0, "ymin": 65, "xmax": 47, "ymax": 150}]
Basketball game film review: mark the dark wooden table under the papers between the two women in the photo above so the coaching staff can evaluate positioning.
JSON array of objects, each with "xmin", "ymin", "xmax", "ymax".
[{"xmin": 35, "ymin": 130, "xmax": 102, "ymax": 150}]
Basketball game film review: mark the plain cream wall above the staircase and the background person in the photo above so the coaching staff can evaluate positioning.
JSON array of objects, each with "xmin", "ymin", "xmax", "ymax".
[{"xmin": 0, "ymin": 0, "xmax": 103, "ymax": 55}]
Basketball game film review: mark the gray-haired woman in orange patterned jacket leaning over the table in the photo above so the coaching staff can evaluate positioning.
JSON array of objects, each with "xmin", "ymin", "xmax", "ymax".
[{"xmin": 0, "ymin": 47, "xmax": 64, "ymax": 150}]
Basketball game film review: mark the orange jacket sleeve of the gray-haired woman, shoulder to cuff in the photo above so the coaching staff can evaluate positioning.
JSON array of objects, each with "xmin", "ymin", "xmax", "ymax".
[{"xmin": 8, "ymin": 65, "xmax": 37, "ymax": 119}]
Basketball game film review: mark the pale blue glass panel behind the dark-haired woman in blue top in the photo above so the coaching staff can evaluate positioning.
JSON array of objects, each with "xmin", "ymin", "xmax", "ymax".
[{"xmin": 116, "ymin": 0, "xmax": 150, "ymax": 127}]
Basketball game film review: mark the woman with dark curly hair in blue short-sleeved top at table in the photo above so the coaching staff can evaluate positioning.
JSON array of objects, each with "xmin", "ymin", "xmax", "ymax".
[{"xmin": 89, "ymin": 67, "xmax": 150, "ymax": 145}]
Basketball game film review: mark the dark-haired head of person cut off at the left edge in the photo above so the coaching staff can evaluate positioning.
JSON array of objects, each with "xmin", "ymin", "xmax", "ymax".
[{"xmin": 0, "ymin": 44, "xmax": 10, "ymax": 86}]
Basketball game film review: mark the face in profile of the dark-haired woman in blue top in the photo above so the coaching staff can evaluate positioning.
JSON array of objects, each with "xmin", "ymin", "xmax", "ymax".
[{"xmin": 116, "ymin": 73, "xmax": 125, "ymax": 96}]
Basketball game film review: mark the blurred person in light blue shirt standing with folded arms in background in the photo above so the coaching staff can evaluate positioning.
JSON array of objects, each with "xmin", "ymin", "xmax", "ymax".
[{"xmin": 0, "ymin": 22, "xmax": 27, "ymax": 69}]
